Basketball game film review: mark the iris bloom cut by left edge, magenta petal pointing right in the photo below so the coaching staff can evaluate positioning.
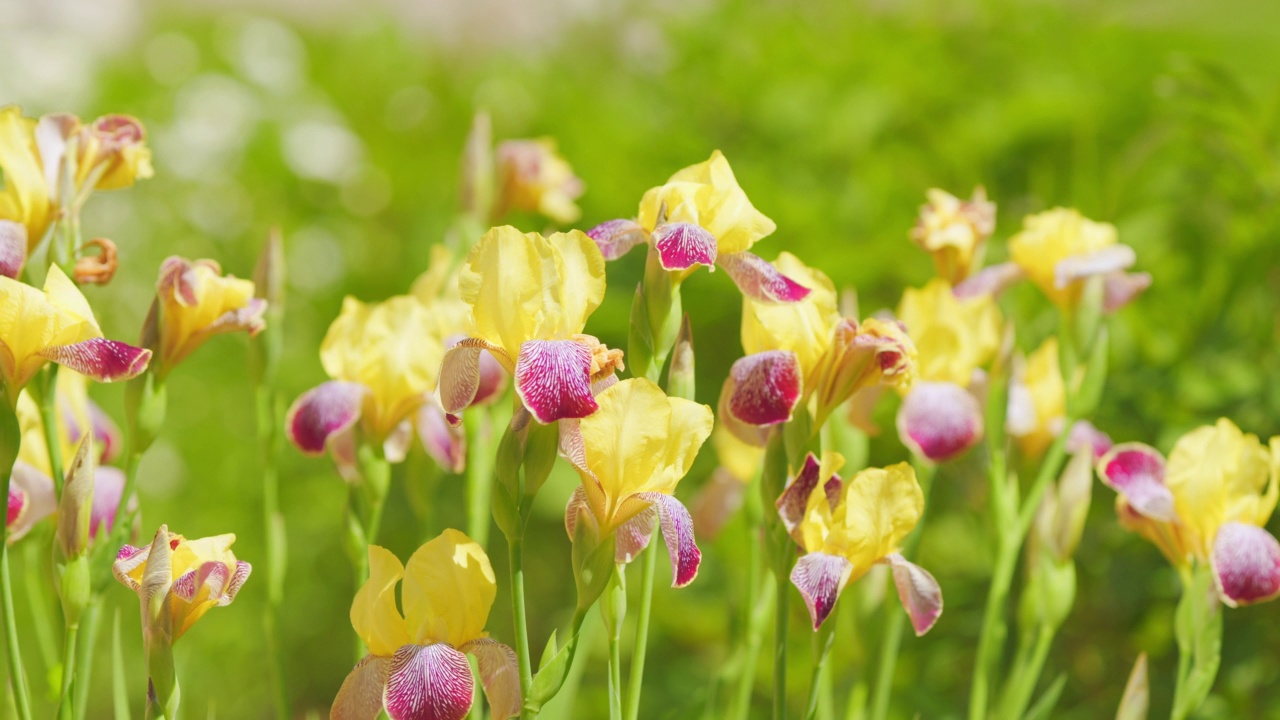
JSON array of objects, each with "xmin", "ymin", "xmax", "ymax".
[{"xmin": 0, "ymin": 265, "xmax": 151, "ymax": 397}]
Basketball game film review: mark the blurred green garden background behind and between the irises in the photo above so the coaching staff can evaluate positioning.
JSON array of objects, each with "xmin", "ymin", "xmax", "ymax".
[{"xmin": 10, "ymin": 0, "xmax": 1280, "ymax": 719}]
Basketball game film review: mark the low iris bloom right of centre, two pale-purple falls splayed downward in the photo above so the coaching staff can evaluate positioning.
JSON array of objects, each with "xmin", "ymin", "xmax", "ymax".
[{"xmin": 777, "ymin": 454, "xmax": 942, "ymax": 635}]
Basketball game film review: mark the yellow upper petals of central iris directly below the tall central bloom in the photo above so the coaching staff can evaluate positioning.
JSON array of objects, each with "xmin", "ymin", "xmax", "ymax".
[{"xmin": 579, "ymin": 378, "xmax": 714, "ymax": 533}]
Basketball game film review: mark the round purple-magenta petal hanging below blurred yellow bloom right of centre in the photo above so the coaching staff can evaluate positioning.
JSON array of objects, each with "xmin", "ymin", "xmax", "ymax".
[{"xmin": 897, "ymin": 382, "xmax": 983, "ymax": 462}]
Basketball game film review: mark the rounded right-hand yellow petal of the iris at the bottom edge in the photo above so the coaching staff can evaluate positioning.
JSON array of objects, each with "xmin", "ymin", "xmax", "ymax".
[{"xmin": 402, "ymin": 529, "xmax": 498, "ymax": 647}]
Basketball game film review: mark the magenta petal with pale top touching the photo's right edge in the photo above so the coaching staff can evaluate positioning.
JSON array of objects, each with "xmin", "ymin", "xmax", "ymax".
[{"xmin": 1213, "ymin": 523, "xmax": 1280, "ymax": 607}]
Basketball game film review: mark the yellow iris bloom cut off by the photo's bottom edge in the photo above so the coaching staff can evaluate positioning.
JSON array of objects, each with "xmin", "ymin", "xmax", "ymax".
[{"xmin": 329, "ymin": 529, "xmax": 522, "ymax": 720}]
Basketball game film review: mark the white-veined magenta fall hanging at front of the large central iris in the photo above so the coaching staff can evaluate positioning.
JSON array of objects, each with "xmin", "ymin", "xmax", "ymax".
[{"xmin": 516, "ymin": 340, "xmax": 599, "ymax": 424}]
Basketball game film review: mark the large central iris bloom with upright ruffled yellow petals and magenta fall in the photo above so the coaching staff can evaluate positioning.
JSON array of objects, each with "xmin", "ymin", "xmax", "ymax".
[{"xmin": 440, "ymin": 225, "xmax": 622, "ymax": 423}]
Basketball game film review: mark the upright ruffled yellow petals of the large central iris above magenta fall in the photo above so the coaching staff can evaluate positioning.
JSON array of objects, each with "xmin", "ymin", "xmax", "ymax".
[{"xmin": 458, "ymin": 225, "xmax": 604, "ymax": 357}]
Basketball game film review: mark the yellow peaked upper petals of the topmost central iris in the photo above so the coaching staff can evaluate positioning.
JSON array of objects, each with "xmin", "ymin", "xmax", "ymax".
[{"xmin": 639, "ymin": 150, "xmax": 777, "ymax": 254}]
